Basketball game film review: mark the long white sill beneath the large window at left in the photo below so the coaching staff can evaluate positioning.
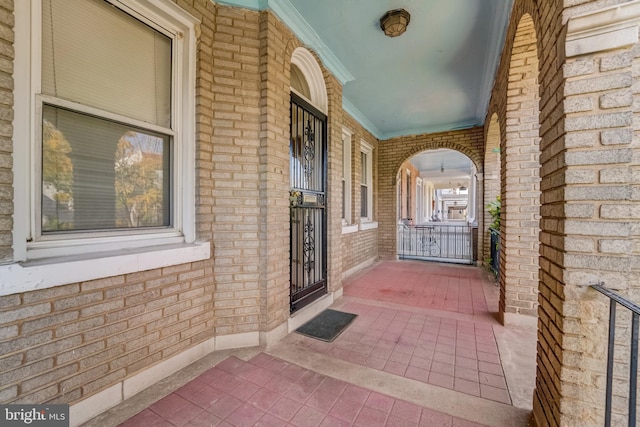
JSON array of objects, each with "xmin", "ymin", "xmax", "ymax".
[{"xmin": 0, "ymin": 242, "xmax": 211, "ymax": 296}]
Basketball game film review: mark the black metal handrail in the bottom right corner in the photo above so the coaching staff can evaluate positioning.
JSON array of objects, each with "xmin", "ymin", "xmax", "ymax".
[{"xmin": 591, "ymin": 283, "xmax": 640, "ymax": 427}]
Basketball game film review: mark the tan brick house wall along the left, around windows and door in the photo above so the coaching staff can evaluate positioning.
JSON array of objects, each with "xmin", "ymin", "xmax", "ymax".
[{"xmin": 0, "ymin": 0, "xmax": 377, "ymax": 410}]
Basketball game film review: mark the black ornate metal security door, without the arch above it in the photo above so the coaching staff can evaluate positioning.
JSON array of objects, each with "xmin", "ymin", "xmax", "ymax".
[{"xmin": 289, "ymin": 94, "xmax": 327, "ymax": 312}]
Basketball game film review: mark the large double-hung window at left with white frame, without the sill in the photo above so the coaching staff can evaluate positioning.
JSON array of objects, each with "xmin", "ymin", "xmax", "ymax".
[{"xmin": 14, "ymin": 0, "xmax": 197, "ymax": 260}]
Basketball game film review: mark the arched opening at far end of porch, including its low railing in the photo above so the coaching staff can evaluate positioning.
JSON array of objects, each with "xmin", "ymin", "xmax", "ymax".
[{"xmin": 396, "ymin": 149, "xmax": 477, "ymax": 264}]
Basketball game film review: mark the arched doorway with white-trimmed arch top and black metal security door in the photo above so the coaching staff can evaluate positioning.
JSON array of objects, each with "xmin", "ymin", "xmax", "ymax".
[{"xmin": 289, "ymin": 48, "xmax": 328, "ymax": 312}]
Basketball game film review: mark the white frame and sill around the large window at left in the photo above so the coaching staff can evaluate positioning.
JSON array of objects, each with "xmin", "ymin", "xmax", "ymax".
[{"xmin": 6, "ymin": 0, "xmax": 210, "ymax": 294}]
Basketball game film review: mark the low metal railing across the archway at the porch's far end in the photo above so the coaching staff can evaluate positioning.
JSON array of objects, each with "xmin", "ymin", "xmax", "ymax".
[{"xmin": 398, "ymin": 223, "xmax": 473, "ymax": 263}]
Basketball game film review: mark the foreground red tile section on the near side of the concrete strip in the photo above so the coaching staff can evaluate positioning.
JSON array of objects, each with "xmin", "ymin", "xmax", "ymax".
[{"xmin": 121, "ymin": 353, "xmax": 480, "ymax": 427}]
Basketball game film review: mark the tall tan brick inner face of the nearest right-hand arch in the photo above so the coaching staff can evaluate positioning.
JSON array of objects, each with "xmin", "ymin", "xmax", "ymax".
[{"xmin": 499, "ymin": 14, "xmax": 540, "ymax": 325}]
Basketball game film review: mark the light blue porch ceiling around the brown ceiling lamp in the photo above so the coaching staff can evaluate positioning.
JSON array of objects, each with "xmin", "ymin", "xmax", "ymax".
[{"xmin": 222, "ymin": 0, "xmax": 513, "ymax": 140}]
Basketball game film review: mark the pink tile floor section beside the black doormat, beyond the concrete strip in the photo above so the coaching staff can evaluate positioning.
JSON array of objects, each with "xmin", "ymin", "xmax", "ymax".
[{"xmin": 286, "ymin": 302, "xmax": 511, "ymax": 404}]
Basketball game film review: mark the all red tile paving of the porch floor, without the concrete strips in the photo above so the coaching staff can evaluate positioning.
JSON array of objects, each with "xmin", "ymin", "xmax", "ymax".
[{"xmin": 120, "ymin": 261, "xmax": 536, "ymax": 427}]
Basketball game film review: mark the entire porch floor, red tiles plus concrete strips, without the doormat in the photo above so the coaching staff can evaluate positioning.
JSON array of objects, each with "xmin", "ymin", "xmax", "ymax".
[{"xmin": 86, "ymin": 261, "xmax": 536, "ymax": 427}]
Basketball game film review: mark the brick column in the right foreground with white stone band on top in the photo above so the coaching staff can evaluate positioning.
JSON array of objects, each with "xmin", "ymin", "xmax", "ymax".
[{"xmin": 534, "ymin": 1, "xmax": 640, "ymax": 426}]
